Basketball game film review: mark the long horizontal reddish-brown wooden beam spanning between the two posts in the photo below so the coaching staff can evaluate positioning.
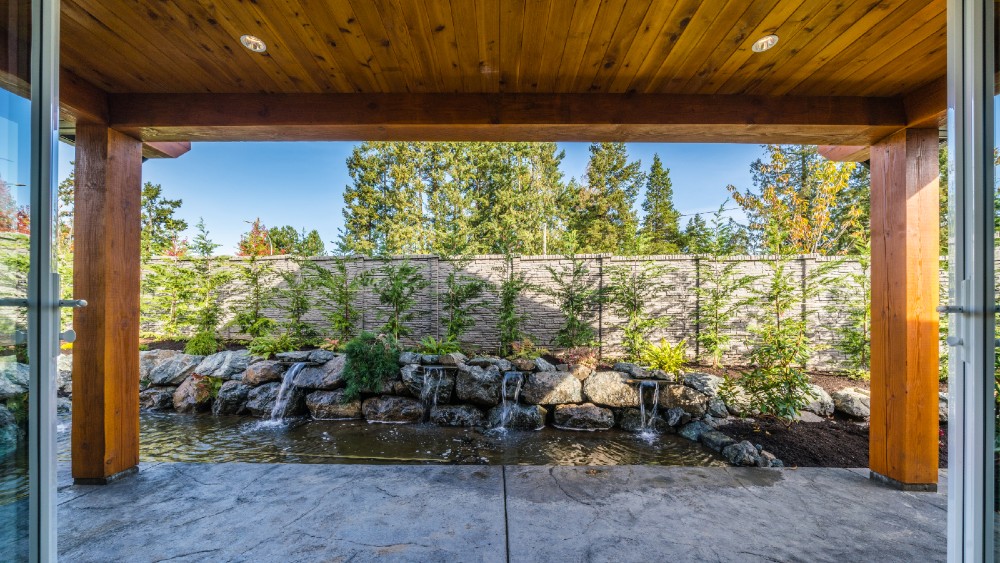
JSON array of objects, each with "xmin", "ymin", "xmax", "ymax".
[{"xmin": 110, "ymin": 94, "xmax": 906, "ymax": 145}]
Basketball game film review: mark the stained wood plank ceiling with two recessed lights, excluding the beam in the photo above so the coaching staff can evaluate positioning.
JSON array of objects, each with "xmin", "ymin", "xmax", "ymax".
[{"xmin": 62, "ymin": 0, "xmax": 946, "ymax": 97}]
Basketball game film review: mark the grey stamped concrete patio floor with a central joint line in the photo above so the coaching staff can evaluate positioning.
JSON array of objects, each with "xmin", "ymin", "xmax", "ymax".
[{"xmin": 58, "ymin": 463, "xmax": 947, "ymax": 562}]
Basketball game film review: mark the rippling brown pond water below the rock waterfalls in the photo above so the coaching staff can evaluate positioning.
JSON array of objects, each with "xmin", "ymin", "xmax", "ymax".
[{"xmin": 0, "ymin": 412, "xmax": 726, "ymax": 505}]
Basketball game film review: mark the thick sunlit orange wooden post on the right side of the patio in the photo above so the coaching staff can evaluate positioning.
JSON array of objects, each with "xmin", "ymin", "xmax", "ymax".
[{"xmin": 869, "ymin": 129, "xmax": 939, "ymax": 490}]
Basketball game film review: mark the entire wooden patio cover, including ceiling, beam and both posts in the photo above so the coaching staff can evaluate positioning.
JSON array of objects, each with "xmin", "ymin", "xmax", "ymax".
[{"xmin": 11, "ymin": 0, "xmax": 946, "ymax": 486}]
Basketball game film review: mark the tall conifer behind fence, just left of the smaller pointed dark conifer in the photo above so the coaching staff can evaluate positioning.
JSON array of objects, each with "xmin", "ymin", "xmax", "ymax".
[{"xmin": 570, "ymin": 143, "xmax": 645, "ymax": 252}]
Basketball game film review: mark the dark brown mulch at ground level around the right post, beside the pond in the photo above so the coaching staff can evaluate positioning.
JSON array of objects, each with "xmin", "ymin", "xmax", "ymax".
[{"xmin": 720, "ymin": 420, "xmax": 948, "ymax": 467}]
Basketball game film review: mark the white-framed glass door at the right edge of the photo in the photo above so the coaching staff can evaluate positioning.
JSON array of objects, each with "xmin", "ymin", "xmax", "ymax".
[{"xmin": 947, "ymin": 0, "xmax": 997, "ymax": 561}]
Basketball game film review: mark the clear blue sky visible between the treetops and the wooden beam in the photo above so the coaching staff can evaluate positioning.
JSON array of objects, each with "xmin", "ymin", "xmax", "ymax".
[{"xmin": 59, "ymin": 142, "xmax": 763, "ymax": 254}]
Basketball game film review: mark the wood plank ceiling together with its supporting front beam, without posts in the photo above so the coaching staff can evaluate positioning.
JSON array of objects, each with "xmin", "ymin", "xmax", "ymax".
[{"xmin": 7, "ymin": 0, "xmax": 947, "ymax": 146}]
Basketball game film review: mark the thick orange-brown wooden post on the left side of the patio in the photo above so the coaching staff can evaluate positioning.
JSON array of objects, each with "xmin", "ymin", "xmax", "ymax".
[{"xmin": 72, "ymin": 123, "xmax": 142, "ymax": 484}]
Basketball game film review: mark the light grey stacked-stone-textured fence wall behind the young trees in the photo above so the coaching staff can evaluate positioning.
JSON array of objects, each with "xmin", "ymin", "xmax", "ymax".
[{"xmin": 143, "ymin": 254, "xmax": 916, "ymax": 371}]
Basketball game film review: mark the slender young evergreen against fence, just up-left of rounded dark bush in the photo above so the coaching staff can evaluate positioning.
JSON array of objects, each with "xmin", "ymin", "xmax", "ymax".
[{"xmin": 305, "ymin": 256, "xmax": 371, "ymax": 344}]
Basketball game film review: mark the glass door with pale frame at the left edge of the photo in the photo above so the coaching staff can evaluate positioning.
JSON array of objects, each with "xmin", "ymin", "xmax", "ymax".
[{"xmin": 0, "ymin": 0, "xmax": 59, "ymax": 561}]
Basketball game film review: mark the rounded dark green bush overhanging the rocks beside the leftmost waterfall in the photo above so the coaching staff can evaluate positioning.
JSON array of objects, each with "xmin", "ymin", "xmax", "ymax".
[{"xmin": 344, "ymin": 332, "xmax": 399, "ymax": 401}]
